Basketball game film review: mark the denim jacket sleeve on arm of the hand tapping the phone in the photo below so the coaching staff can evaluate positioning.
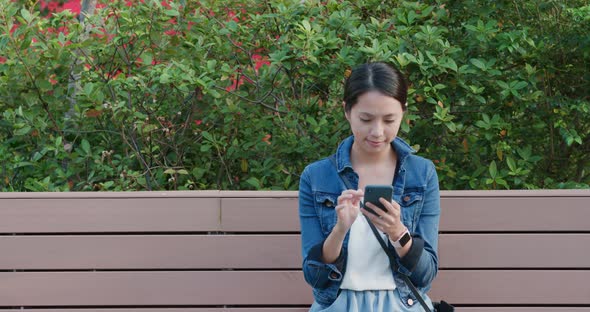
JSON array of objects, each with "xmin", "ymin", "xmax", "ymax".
[{"xmin": 299, "ymin": 168, "xmax": 346, "ymax": 289}]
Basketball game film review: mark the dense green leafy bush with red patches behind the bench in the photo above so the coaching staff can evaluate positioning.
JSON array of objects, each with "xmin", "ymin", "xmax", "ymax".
[{"xmin": 0, "ymin": 0, "xmax": 590, "ymax": 191}]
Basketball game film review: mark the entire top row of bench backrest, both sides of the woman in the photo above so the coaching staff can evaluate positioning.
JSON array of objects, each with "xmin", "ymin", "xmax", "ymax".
[{"xmin": 0, "ymin": 191, "xmax": 590, "ymax": 233}]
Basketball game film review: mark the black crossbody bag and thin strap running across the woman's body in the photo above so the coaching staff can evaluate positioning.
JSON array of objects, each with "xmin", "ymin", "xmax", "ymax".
[{"xmin": 330, "ymin": 155, "xmax": 455, "ymax": 312}]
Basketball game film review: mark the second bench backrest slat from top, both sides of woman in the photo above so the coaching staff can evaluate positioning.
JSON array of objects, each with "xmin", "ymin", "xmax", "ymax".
[{"xmin": 0, "ymin": 234, "xmax": 590, "ymax": 270}]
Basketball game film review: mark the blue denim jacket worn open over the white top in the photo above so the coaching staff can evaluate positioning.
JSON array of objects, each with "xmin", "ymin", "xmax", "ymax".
[{"xmin": 299, "ymin": 136, "xmax": 440, "ymax": 308}]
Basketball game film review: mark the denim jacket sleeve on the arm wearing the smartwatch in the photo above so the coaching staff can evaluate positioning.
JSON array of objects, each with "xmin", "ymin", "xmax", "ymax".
[{"xmin": 389, "ymin": 161, "xmax": 440, "ymax": 288}]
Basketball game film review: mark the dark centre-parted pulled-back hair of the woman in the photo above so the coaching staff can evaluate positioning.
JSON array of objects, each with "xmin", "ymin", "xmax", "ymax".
[{"xmin": 344, "ymin": 62, "xmax": 408, "ymax": 112}]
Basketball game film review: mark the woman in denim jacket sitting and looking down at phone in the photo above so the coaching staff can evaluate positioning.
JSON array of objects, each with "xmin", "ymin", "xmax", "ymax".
[{"xmin": 299, "ymin": 62, "xmax": 440, "ymax": 311}]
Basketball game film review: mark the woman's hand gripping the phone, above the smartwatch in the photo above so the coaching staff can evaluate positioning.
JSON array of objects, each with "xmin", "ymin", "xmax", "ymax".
[{"xmin": 361, "ymin": 197, "xmax": 406, "ymax": 239}]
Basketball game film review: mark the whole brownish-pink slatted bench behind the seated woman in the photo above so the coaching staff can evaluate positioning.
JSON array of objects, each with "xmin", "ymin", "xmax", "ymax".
[{"xmin": 0, "ymin": 190, "xmax": 590, "ymax": 312}]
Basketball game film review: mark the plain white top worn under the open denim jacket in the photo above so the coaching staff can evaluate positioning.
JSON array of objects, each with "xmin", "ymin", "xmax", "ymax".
[{"xmin": 340, "ymin": 213, "xmax": 395, "ymax": 291}]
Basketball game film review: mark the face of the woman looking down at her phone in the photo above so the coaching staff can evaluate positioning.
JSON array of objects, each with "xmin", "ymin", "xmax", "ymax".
[{"xmin": 346, "ymin": 91, "xmax": 404, "ymax": 154}]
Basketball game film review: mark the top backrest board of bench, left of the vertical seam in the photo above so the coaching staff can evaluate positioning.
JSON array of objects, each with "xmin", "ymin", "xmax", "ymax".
[{"xmin": 0, "ymin": 199, "xmax": 221, "ymax": 233}]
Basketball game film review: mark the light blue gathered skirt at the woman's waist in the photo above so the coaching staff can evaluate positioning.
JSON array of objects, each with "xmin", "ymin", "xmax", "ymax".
[{"xmin": 309, "ymin": 289, "xmax": 431, "ymax": 312}]
